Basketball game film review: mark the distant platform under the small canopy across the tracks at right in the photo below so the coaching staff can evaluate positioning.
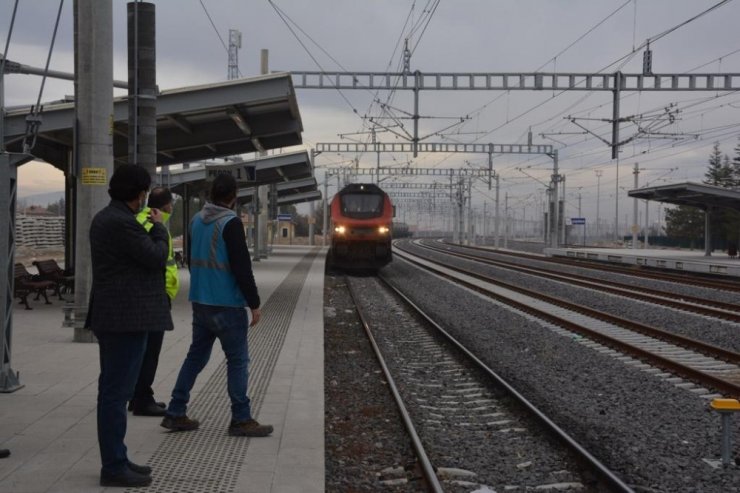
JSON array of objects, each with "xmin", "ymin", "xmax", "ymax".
[{"xmin": 544, "ymin": 248, "xmax": 740, "ymax": 277}]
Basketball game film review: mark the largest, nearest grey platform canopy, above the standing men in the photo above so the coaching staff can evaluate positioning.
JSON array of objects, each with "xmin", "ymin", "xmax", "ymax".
[{"xmin": 5, "ymin": 73, "xmax": 303, "ymax": 172}]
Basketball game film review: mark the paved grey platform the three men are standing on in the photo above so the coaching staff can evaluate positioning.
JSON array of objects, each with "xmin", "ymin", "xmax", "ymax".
[{"xmin": 0, "ymin": 246, "xmax": 326, "ymax": 493}]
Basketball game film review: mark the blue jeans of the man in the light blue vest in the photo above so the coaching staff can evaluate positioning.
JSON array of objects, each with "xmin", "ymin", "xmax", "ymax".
[{"xmin": 167, "ymin": 303, "xmax": 252, "ymax": 421}]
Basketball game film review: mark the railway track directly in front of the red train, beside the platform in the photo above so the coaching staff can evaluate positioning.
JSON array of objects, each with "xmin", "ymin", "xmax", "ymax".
[{"xmin": 347, "ymin": 278, "xmax": 632, "ymax": 492}]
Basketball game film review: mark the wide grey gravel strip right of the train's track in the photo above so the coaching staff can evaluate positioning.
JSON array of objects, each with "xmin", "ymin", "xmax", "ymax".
[{"xmin": 378, "ymin": 259, "xmax": 740, "ymax": 493}]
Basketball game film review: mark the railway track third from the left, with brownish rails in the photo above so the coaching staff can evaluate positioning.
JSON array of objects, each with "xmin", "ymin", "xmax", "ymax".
[{"xmin": 415, "ymin": 241, "xmax": 740, "ymax": 323}]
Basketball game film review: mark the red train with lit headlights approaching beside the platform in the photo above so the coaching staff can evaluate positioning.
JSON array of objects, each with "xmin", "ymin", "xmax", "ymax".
[{"xmin": 329, "ymin": 183, "xmax": 393, "ymax": 269}]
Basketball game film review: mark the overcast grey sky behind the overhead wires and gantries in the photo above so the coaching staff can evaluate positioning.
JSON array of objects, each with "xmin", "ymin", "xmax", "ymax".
[{"xmin": 0, "ymin": 0, "xmax": 740, "ymax": 231}]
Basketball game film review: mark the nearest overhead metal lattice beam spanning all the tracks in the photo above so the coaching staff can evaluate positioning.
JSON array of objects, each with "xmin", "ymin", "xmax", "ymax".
[{"xmin": 290, "ymin": 72, "xmax": 740, "ymax": 91}]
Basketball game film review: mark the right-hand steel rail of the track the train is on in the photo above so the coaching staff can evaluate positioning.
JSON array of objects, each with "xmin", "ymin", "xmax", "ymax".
[{"xmin": 378, "ymin": 275, "xmax": 634, "ymax": 492}]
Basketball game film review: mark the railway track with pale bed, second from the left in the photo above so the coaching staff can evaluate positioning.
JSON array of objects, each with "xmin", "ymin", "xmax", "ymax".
[{"xmin": 396, "ymin": 242, "xmax": 740, "ymax": 395}]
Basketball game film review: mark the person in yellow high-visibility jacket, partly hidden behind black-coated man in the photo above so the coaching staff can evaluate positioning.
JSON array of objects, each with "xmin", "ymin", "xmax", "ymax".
[{"xmin": 128, "ymin": 187, "xmax": 180, "ymax": 416}]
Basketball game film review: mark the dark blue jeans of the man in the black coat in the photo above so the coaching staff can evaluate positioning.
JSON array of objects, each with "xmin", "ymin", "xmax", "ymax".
[{"xmin": 95, "ymin": 331, "xmax": 147, "ymax": 475}]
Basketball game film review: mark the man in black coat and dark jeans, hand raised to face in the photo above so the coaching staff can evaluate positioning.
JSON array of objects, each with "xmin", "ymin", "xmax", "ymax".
[{"xmin": 88, "ymin": 164, "xmax": 173, "ymax": 487}]
